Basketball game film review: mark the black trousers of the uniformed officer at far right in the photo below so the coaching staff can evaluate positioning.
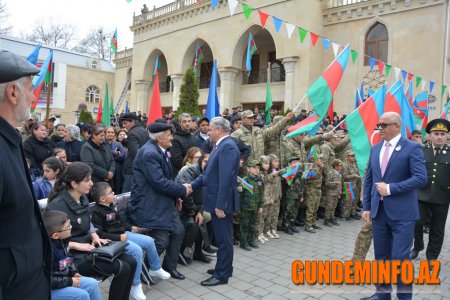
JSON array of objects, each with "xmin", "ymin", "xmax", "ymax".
[{"xmin": 414, "ymin": 201, "xmax": 449, "ymax": 260}]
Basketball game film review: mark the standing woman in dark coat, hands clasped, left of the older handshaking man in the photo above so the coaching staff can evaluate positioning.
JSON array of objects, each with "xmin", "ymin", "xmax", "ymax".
[{"xmin": 80, "ymin": 125, "xmax": 116, "ymax": 185}]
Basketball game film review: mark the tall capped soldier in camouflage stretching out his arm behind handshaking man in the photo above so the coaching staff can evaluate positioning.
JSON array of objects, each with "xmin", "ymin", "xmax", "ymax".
[{"xmin": 231, "ymin": 110, "xmax": 294, "ymax": 160}]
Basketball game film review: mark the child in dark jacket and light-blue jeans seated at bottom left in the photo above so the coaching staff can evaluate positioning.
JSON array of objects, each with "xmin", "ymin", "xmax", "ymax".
[{"xmin": 42, "ymin": 210, "xmax": 102, "ymax": 300}]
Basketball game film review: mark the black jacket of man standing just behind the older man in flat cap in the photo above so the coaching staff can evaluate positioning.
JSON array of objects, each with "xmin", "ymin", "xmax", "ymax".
[{"xmin": 170, "ymin": 125, "xmax": 198, "ymax": 176}]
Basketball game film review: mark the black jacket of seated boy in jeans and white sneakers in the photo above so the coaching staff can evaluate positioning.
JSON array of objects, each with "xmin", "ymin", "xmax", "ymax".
[{"xmin": 92, "ymin": 204, "xmax": 131, "ymax": 241}]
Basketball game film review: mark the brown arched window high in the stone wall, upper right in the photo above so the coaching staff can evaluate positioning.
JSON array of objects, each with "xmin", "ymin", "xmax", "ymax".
[{"xmin": 364, "ymin": 22, "xmax": 389, "ymax": 66}]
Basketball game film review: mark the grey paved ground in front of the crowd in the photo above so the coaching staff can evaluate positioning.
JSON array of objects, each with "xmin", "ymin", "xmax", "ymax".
[{"xmin": 101, "ymin": 219, "xmax": 450, "ymax": 300}]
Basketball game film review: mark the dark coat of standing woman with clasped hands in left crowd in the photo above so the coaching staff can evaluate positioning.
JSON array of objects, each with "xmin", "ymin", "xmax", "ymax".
[{"xmin": 80, "ymin": 139, "xmax": 116, "ymax": 183}]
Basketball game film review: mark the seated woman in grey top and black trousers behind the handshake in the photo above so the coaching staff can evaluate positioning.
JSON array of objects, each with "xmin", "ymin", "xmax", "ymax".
[{"xmin": 175, "ymin": 151, "xmax": 211, "ymax": 265}]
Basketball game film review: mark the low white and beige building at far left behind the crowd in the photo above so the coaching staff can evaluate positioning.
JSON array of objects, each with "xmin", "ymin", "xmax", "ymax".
[{"xmin": 0, "ymin": 36, "xmax": 115, "ymax": 124}]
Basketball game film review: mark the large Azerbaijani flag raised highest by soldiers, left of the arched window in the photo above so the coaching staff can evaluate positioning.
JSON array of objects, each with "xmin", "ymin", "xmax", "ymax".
[{"xmin": 286, "ymin": 45, "xmax": 350, "ymax": 138}]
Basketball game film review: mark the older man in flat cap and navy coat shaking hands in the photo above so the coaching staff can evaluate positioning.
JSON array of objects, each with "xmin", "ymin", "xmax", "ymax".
[{"xmin": 127, "ymin": 122, "xmax": 192, "ymax": 279}]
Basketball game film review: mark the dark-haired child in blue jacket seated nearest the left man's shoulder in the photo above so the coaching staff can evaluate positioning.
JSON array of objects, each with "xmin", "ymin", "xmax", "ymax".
[{"xmin": 33, "ymin": 156, "xmax": 64, "ymax": 200}]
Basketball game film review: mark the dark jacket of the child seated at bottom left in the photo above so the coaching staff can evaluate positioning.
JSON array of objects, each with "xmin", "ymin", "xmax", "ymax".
[{"xmin": 51, "ymin": 240, "xmax": 77, "ymax": 290}]
